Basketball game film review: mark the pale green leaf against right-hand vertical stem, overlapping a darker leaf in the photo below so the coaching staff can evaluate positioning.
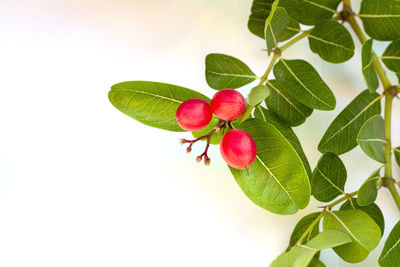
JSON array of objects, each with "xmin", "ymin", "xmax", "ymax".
[{"xmin": 357, "ymin": 115, "xmax": 386, "ymax": 163}]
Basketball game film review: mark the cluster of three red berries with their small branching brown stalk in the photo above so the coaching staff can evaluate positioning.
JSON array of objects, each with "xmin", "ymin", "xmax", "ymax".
[{"xmin": 176, "ymin": 89, "xmax": 257, "ymax": 169}]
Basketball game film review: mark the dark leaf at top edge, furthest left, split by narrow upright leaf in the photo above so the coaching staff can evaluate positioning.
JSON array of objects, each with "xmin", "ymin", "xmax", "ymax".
[{"xmin": 247, "ymin": 0, "xmax": 300, "ymax": 42}]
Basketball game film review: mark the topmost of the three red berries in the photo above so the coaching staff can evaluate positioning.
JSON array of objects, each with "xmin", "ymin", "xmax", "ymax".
[{"xmin": 211, "ymin": 89, "xmax": 246, "ymax": 121}]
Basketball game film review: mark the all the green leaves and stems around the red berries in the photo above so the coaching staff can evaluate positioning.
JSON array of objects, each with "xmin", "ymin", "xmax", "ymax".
[{"xmin": 109, "ymin": 0, "xmax": 400, "ymax": 267}]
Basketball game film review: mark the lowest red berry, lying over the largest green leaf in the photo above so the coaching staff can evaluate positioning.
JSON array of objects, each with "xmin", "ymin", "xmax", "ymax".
[{"xmin": 219, "ymin": 129, "xmax": 257, "ymax": 169}]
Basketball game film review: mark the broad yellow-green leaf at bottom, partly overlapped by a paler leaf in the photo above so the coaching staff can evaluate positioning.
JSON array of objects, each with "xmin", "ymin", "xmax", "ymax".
[{"xmin": 323, "ymin": 209, "xmax": 381, "ymax": 263}]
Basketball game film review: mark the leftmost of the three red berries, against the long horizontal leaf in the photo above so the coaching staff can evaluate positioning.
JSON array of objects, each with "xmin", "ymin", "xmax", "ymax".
[{"xmin": 176, "ymin": 98, "xmax": 212, "ymax": 132}]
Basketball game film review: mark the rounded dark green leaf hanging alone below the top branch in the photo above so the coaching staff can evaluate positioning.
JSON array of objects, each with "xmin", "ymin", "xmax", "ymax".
[{"xmin": 308, "ymin": 20, "xmax": 355, "ymax": 63}]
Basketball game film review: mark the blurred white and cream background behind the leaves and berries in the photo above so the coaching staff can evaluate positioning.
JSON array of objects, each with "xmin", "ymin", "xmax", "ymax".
[{"xmin": 0, "ymin": 0, "xmax": 400, "ymax": 267}]
